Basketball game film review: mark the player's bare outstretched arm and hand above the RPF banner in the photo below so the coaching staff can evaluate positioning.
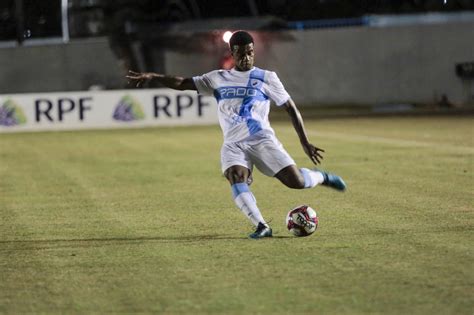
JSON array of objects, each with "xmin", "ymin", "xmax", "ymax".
[{"xmin": 125, "ymin": 70, "xmax": 197, "ymax": 91}]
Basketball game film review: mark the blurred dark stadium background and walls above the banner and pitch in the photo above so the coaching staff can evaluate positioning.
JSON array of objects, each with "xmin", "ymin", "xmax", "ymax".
[{"xmin": 0, "ymin": 0, "xmax": 474, "ymax": 111}]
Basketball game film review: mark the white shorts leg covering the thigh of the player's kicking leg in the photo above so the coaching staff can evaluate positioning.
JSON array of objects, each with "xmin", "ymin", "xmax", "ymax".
[{"xmin": 250, "ymin": 137, "xmax": 296, "ymax": 177}]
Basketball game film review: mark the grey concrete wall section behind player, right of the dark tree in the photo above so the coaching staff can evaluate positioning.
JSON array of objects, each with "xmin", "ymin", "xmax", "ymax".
[{"xmin": 166, "ymin": 23, "xmax": 474, "ymax": 104}]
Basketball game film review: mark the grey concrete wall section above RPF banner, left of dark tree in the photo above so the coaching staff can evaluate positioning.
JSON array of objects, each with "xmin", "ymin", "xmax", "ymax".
[{"xmin": 0, "ymin": 38, "xmax": 125, "ymax": 94}]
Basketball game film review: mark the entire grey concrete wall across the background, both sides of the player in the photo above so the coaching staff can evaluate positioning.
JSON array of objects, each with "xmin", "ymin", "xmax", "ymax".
[{"xmin": 0, "ymin": 22, "xmax": 474, "ymax": 104}]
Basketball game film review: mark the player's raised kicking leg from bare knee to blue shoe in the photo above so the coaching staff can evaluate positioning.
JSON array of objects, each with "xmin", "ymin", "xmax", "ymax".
[{"xmin": 275, "ymin": 165, "xmax": 347, "ymax": 191}]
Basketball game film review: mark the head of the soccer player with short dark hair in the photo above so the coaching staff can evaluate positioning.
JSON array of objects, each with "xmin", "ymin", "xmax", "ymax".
[{"xmin": 229, "ymin": 31, "xmax": 254, "ymax": 71}]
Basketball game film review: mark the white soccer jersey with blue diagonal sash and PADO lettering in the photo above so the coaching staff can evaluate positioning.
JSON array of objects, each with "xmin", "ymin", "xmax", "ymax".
[{"xmin": 193, "ymin": 67, "xmax": 290, "ymax": 142}]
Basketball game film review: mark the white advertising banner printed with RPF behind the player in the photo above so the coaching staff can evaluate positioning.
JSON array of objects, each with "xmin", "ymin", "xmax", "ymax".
[{"xmin": 0, "ymin": 89, "xmax": 218, "ymax": 133}]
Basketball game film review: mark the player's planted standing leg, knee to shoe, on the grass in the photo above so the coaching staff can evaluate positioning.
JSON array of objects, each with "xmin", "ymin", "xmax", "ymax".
[{"xmin": 224, "ymin": 165, "xmax": 272, "ymax": 239}]
